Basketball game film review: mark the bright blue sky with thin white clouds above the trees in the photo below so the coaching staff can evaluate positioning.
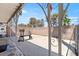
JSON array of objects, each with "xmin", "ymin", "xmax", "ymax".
[{"xmin": 18, "ymin": 3, "xmax": 79, "ymax": 26}]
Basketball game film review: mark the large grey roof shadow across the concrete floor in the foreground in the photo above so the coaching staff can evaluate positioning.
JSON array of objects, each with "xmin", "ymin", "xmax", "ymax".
[{"xmin": 16, "ymin": 41, "xmax": 58, "ymax": 56}]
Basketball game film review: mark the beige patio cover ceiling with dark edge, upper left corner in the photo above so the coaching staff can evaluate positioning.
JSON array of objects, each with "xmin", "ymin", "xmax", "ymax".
[{"xmin": 0, "ymin": 3, "xmax": 21, "ymax": 23}]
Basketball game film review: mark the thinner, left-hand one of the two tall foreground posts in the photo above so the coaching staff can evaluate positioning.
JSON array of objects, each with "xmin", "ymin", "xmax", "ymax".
[{"xmin": 48, "ymin": 3, "xmax": 51, "ymax": 56}]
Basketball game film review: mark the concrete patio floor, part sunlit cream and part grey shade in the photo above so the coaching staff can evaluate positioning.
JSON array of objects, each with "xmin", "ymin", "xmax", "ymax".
[{"xmin": 8, "ymin": 35, "xmax": 75, "ymax": 56}]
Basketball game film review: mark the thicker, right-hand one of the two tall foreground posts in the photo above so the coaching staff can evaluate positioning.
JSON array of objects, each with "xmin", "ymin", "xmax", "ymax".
[{"xmin": 58, "ymin": 3, "xmax": 63, "ymax": 56}]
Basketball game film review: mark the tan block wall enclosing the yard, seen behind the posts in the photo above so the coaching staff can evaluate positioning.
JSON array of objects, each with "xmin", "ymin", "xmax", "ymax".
[{"xmin": 17, "ymin": 26, "xmax": 74, "ymax": 39}]
